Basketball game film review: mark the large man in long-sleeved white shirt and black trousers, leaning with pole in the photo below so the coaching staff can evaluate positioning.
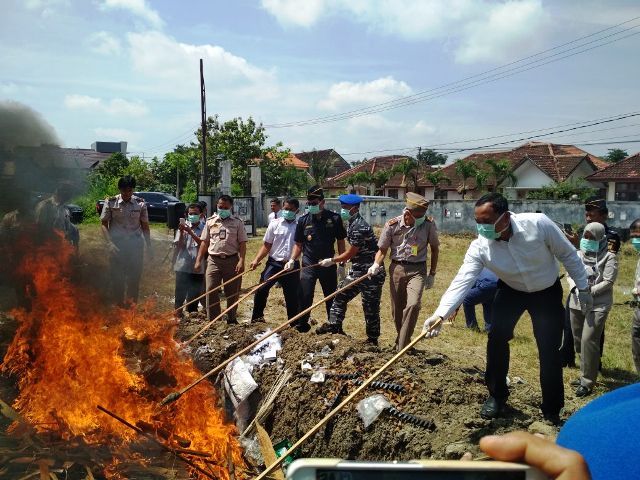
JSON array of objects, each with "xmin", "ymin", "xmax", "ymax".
[{"xmin": 424, "ymin": 193, "xmax": 593, "ymax": 424}]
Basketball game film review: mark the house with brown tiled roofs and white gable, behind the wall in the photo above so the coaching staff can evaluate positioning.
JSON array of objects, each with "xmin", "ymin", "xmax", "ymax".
[{"xmin": 437, "ymin": 142, "xmax": 608, "ymax": 200}]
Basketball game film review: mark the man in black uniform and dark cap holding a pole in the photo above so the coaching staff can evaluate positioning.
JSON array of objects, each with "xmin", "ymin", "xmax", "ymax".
[{"xmin": 285, "ymin": 185, "xmax": 347, "ymax": 332}]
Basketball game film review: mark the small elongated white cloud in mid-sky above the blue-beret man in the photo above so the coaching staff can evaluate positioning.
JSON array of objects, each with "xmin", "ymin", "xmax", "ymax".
[{"xmin": 318, "ymin": 77, "xmax": 411, "ymax": 110}]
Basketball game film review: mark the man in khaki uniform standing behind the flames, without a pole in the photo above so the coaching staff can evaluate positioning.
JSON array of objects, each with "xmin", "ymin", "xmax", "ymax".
[{"xmin": 100, "ymin": 175, "xmax": 153, "ymax": 305}]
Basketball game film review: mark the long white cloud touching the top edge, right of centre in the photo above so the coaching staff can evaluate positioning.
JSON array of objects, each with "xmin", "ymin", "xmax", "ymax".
[{"xmin": 262, "ymin": 0, "xmax": 549, "ymax": 63}]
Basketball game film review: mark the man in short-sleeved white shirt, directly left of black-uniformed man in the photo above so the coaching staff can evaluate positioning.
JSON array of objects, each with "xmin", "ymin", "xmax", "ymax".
[{"xmin": 250, "ymin": 198, "xmax": 300, "ymax": 322}]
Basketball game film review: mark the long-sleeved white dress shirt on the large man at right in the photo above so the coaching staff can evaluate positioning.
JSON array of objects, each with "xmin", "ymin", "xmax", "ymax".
[{"xmin": 435, "ymin": 213, "xmax": 588, "ymax": 318}]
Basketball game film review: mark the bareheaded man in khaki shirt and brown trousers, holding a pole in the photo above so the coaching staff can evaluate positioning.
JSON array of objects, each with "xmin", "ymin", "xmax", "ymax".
[{"xmin": 195, "ymin": 195, "xmax": 247, "ymax": 323}]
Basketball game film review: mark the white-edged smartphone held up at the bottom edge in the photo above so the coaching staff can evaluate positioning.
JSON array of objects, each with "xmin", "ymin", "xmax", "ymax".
[{"xmin": 287, "ymin": 458, "xmax": 549, "ymax": 480}]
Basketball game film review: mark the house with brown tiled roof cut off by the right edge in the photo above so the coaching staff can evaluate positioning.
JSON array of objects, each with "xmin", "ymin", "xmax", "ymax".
[{"xmin": 587, "ymin": 152, "xmax": 640, "ymax": 202}]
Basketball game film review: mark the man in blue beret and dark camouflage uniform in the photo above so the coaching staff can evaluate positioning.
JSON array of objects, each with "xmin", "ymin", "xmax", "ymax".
[{"xmin": 316, "ymin": 194, "xmax": 386, "ymax": 345}]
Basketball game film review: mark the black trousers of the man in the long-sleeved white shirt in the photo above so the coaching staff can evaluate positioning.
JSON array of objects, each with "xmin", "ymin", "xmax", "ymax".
[{"xmin": 485, "ymin": 279, "xmax": 564, "ymax": 414}]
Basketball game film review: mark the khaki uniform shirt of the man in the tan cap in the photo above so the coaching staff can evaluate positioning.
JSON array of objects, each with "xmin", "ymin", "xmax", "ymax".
[{"xmin": 378, "ymin": 215, "xmax": 440, "ymax": 263}]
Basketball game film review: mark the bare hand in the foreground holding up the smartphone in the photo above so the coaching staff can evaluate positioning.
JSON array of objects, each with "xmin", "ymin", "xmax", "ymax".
[{"xmin": 480, "ymin": 432, "xmax": 591, "ymax": 480}]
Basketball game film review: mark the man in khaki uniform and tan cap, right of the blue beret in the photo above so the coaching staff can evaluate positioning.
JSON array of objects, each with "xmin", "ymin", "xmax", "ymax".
[{"xmin": 369, "ymin": 192, "xmax": 440, "ymax": 350}]
